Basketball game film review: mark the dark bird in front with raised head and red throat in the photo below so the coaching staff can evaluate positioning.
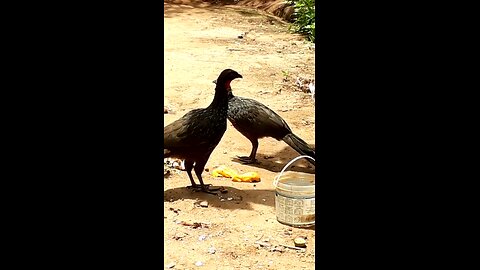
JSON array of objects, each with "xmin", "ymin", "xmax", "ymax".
[{"xmin": 163, "ymin": 69, "xmax": 243, "ymax": 194}]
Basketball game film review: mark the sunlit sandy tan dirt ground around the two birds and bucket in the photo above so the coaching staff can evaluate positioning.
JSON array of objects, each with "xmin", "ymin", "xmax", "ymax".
[{"xmin": 164, "ymin": 0, "xmax": 315, "ymax": 269}]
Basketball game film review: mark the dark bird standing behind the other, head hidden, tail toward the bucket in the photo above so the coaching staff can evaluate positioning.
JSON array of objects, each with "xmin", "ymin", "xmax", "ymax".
[{"xmin": 213, "ymin": 81, "xmax": 315, "ymax": 165}]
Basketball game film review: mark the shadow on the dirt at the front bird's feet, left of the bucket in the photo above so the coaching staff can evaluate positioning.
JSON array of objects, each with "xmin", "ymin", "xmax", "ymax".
[{"xmin": 163, "ymin": 185, "xmax": 275, "ymax": 211}]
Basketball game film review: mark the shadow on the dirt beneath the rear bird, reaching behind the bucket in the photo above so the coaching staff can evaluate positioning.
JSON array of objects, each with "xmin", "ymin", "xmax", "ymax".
[{"xmin": 232, "ymin": 145, "xmax": 315, "ymax": 174}]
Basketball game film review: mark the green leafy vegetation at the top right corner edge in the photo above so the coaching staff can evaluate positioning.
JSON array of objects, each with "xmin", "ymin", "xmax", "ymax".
[{"xmin": 288, "ymin": 0, "xmax": 315, "ymax": 43}]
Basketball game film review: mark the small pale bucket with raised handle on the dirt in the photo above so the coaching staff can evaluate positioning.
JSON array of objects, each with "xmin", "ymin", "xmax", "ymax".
[{"xmin": 273, "ymin": 156, "xmax": 315, "ymax": 227}]
